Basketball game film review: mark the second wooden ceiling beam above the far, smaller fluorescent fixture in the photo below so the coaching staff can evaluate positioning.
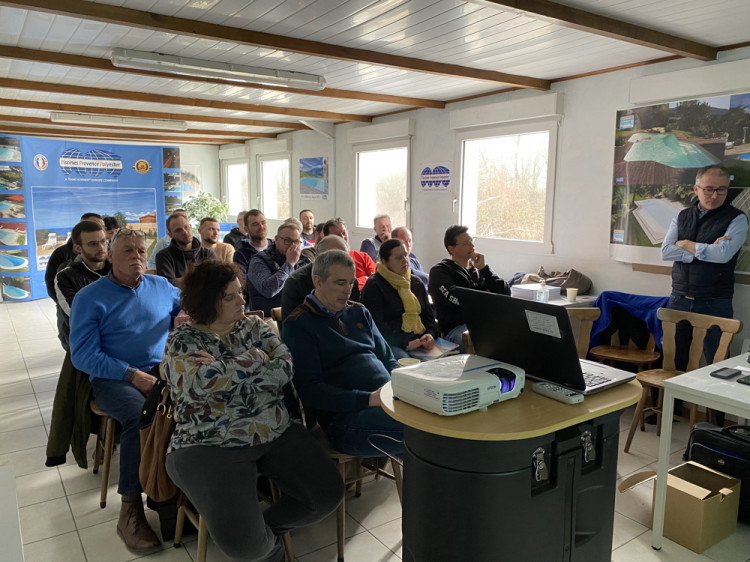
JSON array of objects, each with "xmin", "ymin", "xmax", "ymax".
[{"xmin": 0, "ymin": 78, "xmax": 372, "ymax": 123}]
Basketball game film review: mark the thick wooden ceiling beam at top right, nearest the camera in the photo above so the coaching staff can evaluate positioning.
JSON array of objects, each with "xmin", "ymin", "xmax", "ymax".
[{"xmin": 481, "ymin": 0, "xmax": 718, "ymax": 60}]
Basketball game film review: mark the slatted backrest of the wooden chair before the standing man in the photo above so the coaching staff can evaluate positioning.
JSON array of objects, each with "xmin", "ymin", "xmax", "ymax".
[{"xmin": 657, "ymin": 308, "xmax": 742, "ymax": 371}]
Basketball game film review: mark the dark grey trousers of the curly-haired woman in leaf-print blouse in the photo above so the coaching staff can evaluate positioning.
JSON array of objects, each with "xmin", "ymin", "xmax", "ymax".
[{"xmin": 166, "ymin": 424, "xmax": 344, "ymax": 561}]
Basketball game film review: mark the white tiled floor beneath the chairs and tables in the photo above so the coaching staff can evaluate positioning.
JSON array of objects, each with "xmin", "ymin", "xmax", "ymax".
[{"xmin": 0, "ymin": 299, "xmax": 750, "ymax": 562}]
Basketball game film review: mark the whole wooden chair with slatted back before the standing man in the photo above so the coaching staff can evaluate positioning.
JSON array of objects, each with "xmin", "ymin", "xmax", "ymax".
[{"xmin": 624, "ymin": 308, "xmax": 742, "ymax": 453}]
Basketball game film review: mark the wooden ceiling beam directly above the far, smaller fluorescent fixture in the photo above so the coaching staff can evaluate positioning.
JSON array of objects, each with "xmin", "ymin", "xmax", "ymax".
[{"xmin": 0, "ymin": 98, "xmax": 310, "ymax": 131}]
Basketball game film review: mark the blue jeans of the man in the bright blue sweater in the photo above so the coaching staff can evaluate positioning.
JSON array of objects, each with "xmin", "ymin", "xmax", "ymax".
[{"xmin": 91, "ymin": 377, "xmax": 146, "ymax": 496}]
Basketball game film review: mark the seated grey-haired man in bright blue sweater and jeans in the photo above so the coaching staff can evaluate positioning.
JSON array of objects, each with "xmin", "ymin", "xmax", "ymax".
[{"xmin": 70, "ymin": 229, "xmax": 180, "ymax": 552}]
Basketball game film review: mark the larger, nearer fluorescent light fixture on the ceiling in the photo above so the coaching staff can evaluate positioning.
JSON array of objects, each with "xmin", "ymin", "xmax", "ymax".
[{"xmin": 110, "ymin": 48, "xmax": 326, "ymax": 90}]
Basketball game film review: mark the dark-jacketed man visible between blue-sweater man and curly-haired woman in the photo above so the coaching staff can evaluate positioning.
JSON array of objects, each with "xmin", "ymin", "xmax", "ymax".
[{"xmin": 156, "ymin": 214, "xmax": 216, "ymax": 286}]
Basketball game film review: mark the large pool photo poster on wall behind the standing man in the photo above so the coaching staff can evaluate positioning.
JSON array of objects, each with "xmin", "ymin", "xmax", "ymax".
[{"xmin": 609, "ymin": 93, "xmax": 750, "ymax": 273}]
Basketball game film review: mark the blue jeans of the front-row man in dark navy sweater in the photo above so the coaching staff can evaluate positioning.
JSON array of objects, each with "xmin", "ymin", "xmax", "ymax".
[{"xmin": 326, "ymin": 407, "xmax": 404, "ymax": 457}]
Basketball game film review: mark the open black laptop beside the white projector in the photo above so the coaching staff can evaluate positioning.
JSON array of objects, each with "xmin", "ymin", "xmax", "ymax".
[{"xmin": 455, "ymin": 288, "xmax": 635, "ymax": 394}]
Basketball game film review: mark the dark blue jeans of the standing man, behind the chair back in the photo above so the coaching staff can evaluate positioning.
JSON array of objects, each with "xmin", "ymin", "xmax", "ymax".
[{"xmin": 667, "ymin": 293, "xmax": 733, "ymax": 371}]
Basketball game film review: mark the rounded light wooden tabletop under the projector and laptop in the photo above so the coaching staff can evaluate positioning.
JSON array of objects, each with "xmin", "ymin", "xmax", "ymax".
[{"xmin": 380, "ymin": 380, "xmax": 641, "ymax": 441}]
